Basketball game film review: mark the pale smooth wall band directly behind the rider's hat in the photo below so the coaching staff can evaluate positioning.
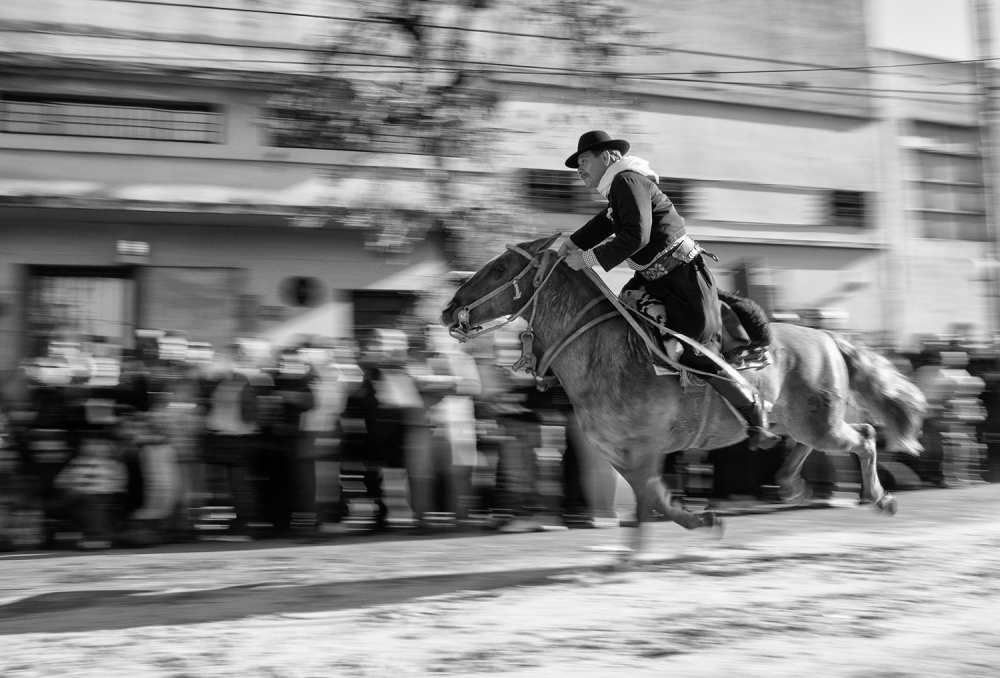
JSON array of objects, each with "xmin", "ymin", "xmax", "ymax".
[{"xmin": 501, "ymin": 91, "xmax": 878, "ymax": 190}]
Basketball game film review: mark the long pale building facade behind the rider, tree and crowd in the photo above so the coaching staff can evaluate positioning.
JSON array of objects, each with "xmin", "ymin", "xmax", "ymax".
[{"xmin": 0, "ymin": 0, "xmax": 995, "ymax": 378}]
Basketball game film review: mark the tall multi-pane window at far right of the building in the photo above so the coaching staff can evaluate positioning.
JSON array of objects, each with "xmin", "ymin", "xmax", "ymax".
[{"xmin": 908, "ymin": 122, "xmax": 989, "ymax": 242}]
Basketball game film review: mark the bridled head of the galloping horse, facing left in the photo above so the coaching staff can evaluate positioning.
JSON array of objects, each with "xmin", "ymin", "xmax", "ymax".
[{"xmin": 441, "ymin": 233, "xmax": 560, "ymax": 341}]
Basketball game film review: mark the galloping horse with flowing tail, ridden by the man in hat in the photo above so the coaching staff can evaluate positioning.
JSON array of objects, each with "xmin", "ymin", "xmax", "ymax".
[{"xmin": 440, "ymin": 234, "xmax": 926, "ymax": 558}]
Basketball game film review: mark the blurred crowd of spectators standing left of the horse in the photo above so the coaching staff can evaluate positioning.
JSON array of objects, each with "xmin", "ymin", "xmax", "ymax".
[{"xmin": 0, "ymin": 323, "xmax": 614, "ymax": 549}]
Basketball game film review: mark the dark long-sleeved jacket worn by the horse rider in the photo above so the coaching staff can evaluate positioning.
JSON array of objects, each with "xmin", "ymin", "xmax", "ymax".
[{"xmin": 570, "ymin": 170, "xmax": 685, "ymax": 271}]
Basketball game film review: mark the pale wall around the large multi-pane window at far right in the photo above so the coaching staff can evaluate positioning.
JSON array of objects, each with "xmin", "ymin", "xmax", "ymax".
[{"xmin": 869, "ymin": 50, "xmax": 998, "ymax": 346}]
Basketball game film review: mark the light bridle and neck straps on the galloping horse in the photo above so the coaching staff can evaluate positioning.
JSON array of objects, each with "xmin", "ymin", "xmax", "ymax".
[{"xmin": 450, "ymin": 245, "xmax": 619, "ymax": 391}]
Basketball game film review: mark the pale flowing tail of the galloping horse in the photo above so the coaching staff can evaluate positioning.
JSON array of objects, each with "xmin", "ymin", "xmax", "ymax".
[{"xmin": 829, "ymin": 332, "xmax": 927, "ymax": 455}]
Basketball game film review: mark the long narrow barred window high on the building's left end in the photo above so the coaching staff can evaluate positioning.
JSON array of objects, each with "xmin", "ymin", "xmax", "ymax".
[{"xmin": 0, "ymin": 93, "xmax": 224, "ymax": 144}]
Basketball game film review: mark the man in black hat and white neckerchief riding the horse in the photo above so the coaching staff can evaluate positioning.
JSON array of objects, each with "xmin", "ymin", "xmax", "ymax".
[{"xmin": 559, "ymin": 131, "xmax": 780, "ymax": 449}]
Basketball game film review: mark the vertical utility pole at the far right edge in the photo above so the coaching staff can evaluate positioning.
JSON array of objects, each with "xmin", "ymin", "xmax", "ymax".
[{"xmin": 972, "ymin": 0, "xmax": 1000, "ymax": 341}]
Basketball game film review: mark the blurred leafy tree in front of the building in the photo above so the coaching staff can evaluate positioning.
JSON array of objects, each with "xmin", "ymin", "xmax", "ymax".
[{"xmin": 265, "ymin": 0, "xmax": 629, "ymax": 266}]
